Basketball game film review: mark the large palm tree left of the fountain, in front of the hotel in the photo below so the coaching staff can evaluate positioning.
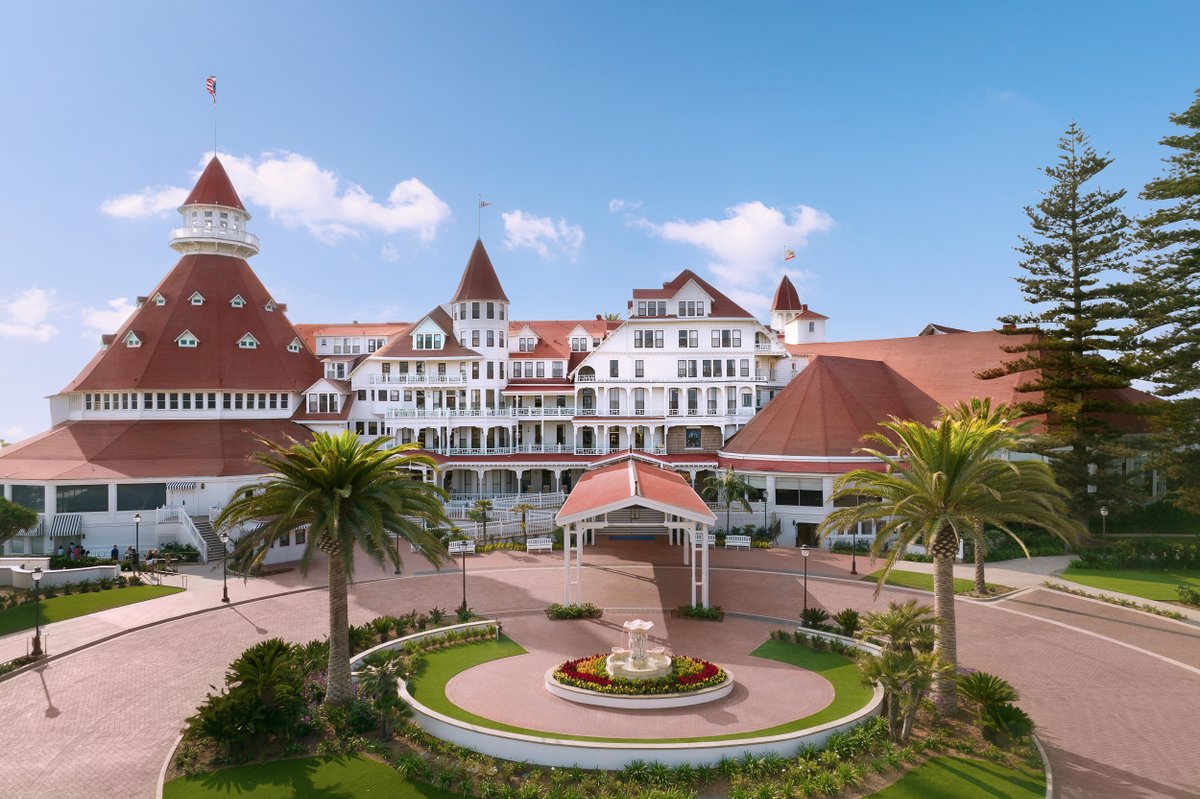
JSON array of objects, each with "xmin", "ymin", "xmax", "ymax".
[{"xmin": 215, "ymin": 432, "xmax": 448, "ymax": 704}]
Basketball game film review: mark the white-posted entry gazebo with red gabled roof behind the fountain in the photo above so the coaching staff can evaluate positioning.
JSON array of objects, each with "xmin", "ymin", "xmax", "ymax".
[{"xmin": 554, "ymin": 457, "xmax": 716, "ymax": 607}]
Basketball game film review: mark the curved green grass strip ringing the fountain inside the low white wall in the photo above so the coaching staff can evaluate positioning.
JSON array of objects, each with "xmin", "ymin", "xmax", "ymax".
[{"xmin": 409, "ymin": 636, "xmax": 874, "ymax": 744}]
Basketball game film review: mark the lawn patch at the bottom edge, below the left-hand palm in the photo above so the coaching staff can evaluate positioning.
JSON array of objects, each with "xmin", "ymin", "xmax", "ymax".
[{"xmin": 162, "ymin": 757, "xmax": 461, "ymax": 799}]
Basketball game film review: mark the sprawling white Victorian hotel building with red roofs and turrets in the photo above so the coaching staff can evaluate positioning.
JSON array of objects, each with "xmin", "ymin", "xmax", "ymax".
[{"xmin": 0, "ymin": 152, "xmax": 1104, "ymax": 559}]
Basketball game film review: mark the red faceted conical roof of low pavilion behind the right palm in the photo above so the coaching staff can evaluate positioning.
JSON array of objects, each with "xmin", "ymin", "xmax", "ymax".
[{"xmin": 721, "ymin": 355, "xmax": 936, "ymax": 457}]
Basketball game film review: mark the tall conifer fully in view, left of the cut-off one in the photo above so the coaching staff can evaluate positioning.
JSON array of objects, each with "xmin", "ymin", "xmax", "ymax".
[{"xmin": 980, "ymin": 122, "xmax": 1147, "ymax": 518}]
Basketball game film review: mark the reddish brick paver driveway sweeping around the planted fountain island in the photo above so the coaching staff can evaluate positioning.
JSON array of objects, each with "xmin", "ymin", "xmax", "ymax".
[{"xmin": 0, "ymin": 545, "xmax": 1200, "ymax": 799}]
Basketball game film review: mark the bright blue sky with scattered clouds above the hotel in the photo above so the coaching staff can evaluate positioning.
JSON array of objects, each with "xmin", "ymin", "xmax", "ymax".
[{"xmin": 0, "ymin": 2, "xmax": 1200, "ymax": 440}]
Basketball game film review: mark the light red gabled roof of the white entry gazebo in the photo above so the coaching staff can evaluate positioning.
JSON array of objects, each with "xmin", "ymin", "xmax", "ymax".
[{"xmin": 554, "ymin": 458, "xmax": 716, "ymax": 524}]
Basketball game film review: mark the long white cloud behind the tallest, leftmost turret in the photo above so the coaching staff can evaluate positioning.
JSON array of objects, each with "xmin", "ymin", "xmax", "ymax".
[{"xmin": 101, "ymin": 151, "xmax": 450, "ymax": 244}]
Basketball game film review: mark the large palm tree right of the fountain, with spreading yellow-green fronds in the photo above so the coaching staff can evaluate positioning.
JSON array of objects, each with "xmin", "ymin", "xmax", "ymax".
[{"xmin": 818, "ymin": 405, "xmax": 1085, "ymax": 713}]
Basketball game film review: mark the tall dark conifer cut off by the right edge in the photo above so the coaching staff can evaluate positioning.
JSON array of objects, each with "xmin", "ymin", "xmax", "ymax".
[{"xmin": 1129, "ymin": 90, "xmax": 1200, "ymax": 513}]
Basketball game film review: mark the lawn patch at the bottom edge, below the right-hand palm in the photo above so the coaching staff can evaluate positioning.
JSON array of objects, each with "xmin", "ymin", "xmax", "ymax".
[{"xmin": 871, "ymin": 757, "xmax": 1046, "ymax": 799}]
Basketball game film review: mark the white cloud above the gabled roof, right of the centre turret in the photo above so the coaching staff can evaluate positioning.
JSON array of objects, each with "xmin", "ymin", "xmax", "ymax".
[{"xmin": 631, "ymin": 200, "xmax": 834, "ymax": 312}]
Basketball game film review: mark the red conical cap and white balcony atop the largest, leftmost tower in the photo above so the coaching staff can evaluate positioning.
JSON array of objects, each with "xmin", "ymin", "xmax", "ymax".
[{"xmin": 170, "ymin": 155, "xmax": 258, "ymax": 258}]
